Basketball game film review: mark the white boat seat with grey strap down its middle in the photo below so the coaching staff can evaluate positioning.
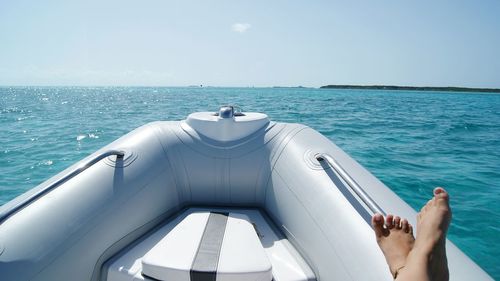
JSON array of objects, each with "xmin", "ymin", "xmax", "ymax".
[{"xmin": 142, "ymin": 211, "xmax": 273, "ymax": 281}]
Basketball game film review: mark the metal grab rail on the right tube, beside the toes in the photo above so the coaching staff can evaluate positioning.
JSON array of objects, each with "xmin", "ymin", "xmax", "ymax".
[{"xmin": 316, "ymin": 153, "xmax": 385, "ymax": 216}]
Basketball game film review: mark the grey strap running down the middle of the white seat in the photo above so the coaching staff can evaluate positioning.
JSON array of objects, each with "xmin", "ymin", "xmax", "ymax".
[{"xmin": 190, "ymin": 212, "xmax": 229, "ymax": 281}]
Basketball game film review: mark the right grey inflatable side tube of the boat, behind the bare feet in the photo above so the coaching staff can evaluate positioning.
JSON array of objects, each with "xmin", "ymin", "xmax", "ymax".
[{"xmin": 265, "ymin": 128, "xmax": 491, "ymax": 281}]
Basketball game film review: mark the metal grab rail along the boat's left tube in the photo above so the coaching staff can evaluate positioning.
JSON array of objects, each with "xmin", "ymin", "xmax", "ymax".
[{"xmin": 0, "ymin": 150, "xmax": 125, "ymax": 225}]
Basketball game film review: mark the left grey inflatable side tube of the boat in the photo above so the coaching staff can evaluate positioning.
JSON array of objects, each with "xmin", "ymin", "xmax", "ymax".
[{"xmin": 0, "ymin": 122, "xmax": 180, "ymax": 280}]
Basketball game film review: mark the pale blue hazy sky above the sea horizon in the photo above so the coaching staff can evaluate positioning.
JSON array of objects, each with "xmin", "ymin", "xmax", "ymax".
[{"xmin": 0, "ymin": 0, "xmax": 500, "ymax": 88}]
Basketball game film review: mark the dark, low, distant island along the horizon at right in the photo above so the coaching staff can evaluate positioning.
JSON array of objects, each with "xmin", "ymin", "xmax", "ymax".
[{"xmin": 320, "ymin": 85, "xmax": 500, "ymax": 93}]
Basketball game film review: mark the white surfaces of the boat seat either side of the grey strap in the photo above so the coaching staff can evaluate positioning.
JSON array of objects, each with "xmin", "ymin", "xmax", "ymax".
[{"xmin": 142, "ymin": 212, "xmax": 272, "ymax": 281}]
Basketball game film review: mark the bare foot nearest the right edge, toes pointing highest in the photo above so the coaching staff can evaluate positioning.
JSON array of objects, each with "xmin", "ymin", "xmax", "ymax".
[{"xmin": 414, "ymin": 187, "xmax": 451, "ymax": 280}]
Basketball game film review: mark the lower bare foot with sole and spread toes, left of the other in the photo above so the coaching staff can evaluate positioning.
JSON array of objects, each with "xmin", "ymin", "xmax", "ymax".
[{"xmin": 372, "ymin": 214, "xmax": 415, "ymax": 278}]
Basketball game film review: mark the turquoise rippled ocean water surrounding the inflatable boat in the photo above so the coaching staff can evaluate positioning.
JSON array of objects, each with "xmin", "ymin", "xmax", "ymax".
[{"xmin": 0, "ymin": 87, "xmax": 500, "ymax": 280}]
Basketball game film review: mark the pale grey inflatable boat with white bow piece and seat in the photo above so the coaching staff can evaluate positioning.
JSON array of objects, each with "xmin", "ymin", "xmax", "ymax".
[{"xmin": 0, "ymin": 106, "xmax": 491, "ymax": 281}]
